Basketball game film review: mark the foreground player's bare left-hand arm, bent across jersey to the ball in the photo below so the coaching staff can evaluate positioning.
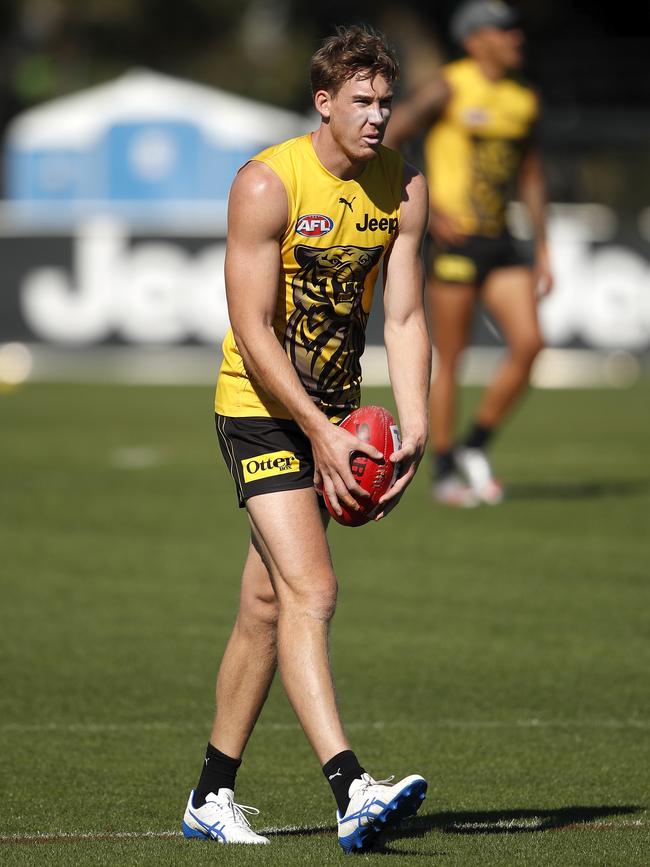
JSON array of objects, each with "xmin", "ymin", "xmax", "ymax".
[{"xmin": 226, "ymin": 161, "xmax": 381, "ymax": 514}]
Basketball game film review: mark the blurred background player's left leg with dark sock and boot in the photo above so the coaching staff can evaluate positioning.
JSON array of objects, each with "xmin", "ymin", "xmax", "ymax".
[{"xmin": 428, "ymin": 280, "xmax": 476, "ymax": 506}]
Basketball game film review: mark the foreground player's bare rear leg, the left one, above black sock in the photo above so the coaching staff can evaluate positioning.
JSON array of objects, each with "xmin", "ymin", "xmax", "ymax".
[{"xmin": 210, "ymin": 538, "xmax": 278, "ymax": 758}]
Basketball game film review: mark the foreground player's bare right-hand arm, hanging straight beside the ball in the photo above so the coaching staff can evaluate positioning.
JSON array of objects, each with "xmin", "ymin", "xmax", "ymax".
[{"xmin": 376, "ymin": 164, "xmax": 431, "ymax": 520}]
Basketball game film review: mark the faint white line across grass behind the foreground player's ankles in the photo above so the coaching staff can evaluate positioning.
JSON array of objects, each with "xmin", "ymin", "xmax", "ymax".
[{"xmin": 0, "ymin": 718, "xmax": 650, "ymax": 734}]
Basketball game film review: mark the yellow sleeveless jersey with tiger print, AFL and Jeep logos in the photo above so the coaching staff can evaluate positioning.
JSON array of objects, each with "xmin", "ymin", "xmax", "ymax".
[{"xmin": 215, "ymin": 134, "xmax": 403, "ymax": 421}]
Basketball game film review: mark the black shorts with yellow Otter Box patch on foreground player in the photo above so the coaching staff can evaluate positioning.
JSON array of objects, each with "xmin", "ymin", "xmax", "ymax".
[{"xmin": 215, "ymin": 413, "xmax": 320, "ymax": 508}]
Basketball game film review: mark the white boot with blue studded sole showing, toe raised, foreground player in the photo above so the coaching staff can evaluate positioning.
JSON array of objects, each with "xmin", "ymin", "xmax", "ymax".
[{"xmin": 336, "ymin": 774, "xmax": 427, "ymax": 854}]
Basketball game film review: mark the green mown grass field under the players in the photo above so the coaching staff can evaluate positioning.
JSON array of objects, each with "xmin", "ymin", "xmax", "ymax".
[{"xmin": 0, "ymin": 382, "xmax": 650, "ymax": 867}]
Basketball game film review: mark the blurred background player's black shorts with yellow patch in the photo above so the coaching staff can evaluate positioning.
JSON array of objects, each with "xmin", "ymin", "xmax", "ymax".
[{"xmin": 431, "ymin": 232, "xmax": 532, "ymax": 288}]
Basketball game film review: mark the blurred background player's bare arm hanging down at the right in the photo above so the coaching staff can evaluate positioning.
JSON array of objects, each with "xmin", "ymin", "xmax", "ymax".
[{"xmin": 517, "ymin": 104, "xmax": 553, "ymax": 297}]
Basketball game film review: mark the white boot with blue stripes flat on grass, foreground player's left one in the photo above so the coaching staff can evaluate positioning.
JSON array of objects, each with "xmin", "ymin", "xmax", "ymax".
[{"xmin": 182, "ymin": 789, "xmax": 269, "ymax": 844}]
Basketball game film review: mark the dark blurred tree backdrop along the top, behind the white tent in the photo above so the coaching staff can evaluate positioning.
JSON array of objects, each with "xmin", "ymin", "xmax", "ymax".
[{"xmin": 0, "ymin": 0, "xmax": 650, "ymax": 209}]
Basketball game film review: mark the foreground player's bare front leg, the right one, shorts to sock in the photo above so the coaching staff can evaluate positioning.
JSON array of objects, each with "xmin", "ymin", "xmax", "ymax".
[{"xmin": 246, "ymin": 488, "xmax": 349, "ymax": 764}]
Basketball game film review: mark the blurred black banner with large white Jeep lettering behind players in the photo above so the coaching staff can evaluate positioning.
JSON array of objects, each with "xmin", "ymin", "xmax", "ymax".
[{"xmin": 0, "ymin": 205, "xmax": 650, "ymax": 352}]
